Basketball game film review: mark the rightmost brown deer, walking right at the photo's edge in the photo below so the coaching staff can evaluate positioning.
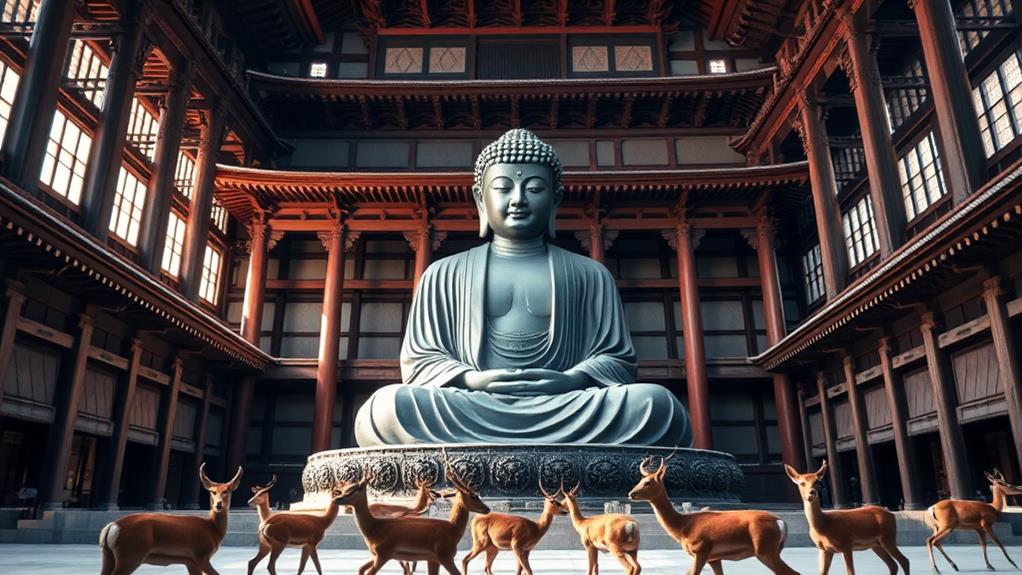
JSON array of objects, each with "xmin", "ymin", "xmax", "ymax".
[{"xmin": 926, "ymin": 470, "xmax": 1022, "ymax": 573}]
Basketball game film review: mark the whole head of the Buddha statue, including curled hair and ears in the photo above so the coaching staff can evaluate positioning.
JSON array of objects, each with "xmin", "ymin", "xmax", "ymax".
[{"xmin": 472, "ymin": 130, "xmax": 564, "ymax": 240}]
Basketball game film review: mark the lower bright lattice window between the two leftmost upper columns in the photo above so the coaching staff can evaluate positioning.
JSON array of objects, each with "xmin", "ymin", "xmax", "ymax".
[{"xmin": 39, "ymin": 109, "xmax": 92, "ymax": 205}]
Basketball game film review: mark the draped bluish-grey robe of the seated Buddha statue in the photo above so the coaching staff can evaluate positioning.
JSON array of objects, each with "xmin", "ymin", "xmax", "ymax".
[{"xmin": 355, "ymin": 244, "xmax": 692, "ymax": 447}]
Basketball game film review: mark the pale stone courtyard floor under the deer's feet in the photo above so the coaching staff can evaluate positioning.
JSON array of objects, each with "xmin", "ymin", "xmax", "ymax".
[{"xmin": 0, "ymin": 544, "xmax": 1022, "ymax": 575}]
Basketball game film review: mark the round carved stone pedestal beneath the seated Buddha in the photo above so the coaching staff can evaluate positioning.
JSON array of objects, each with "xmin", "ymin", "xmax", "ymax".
[{"xmin": 292, "ymin": 443, "xmax": 744, "ymax": 511}]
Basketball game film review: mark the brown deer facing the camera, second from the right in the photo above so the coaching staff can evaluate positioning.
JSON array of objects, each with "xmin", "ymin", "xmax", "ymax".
[{"xmin": 784, "ymin": 461, "xmax": 909, "ymax": 575}]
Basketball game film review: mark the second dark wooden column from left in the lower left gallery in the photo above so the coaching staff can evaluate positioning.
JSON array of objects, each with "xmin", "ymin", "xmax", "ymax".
[{"xmin": 39, "ymin": 314, "xmax": 92, "ymax": 510}]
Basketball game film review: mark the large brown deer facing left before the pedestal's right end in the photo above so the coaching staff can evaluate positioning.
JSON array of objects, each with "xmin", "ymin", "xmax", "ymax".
[{"xmin": 629, "ymin": 453, "xmax": 798, "ymax": 575}]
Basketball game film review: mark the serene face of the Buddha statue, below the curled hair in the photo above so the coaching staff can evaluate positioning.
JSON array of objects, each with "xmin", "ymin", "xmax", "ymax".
[{"xmin": 482, "ymin": 163, "xmax": 557, "ymax": 239}]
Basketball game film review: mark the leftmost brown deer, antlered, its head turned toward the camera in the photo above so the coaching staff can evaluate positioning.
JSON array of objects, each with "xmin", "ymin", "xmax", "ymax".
[{"xmin": 99, "ymin": 463, "xmax": 242, "ymax": 575}]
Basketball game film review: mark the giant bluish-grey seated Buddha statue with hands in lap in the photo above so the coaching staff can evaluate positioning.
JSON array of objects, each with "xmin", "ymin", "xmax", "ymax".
[{"xmin": 355, "ymin": 130, "xmax": 692, "ymax": 447}]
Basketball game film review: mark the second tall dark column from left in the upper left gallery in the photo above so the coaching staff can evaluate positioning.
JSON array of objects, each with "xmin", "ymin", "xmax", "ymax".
[{"xmin": 82, "ymin": 2, "xmax": 151, "ymax": 235}]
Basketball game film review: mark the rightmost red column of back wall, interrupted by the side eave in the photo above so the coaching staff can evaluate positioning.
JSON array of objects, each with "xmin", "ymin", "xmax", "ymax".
[{"xmin": 752, "ymin": 215, "xmax": 805, "ymax": 469}]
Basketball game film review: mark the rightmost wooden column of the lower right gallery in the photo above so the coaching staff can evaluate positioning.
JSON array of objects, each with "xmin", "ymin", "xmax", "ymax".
[{"xmin": 983, "ymin": 276, "xmax": 1022, "ymax": 469}]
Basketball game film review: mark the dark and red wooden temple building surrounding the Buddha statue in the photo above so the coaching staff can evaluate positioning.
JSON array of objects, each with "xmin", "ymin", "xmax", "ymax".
[{"xmin": 0, "ymin": 0, "xmax": 1022, "ymax": 509}]
